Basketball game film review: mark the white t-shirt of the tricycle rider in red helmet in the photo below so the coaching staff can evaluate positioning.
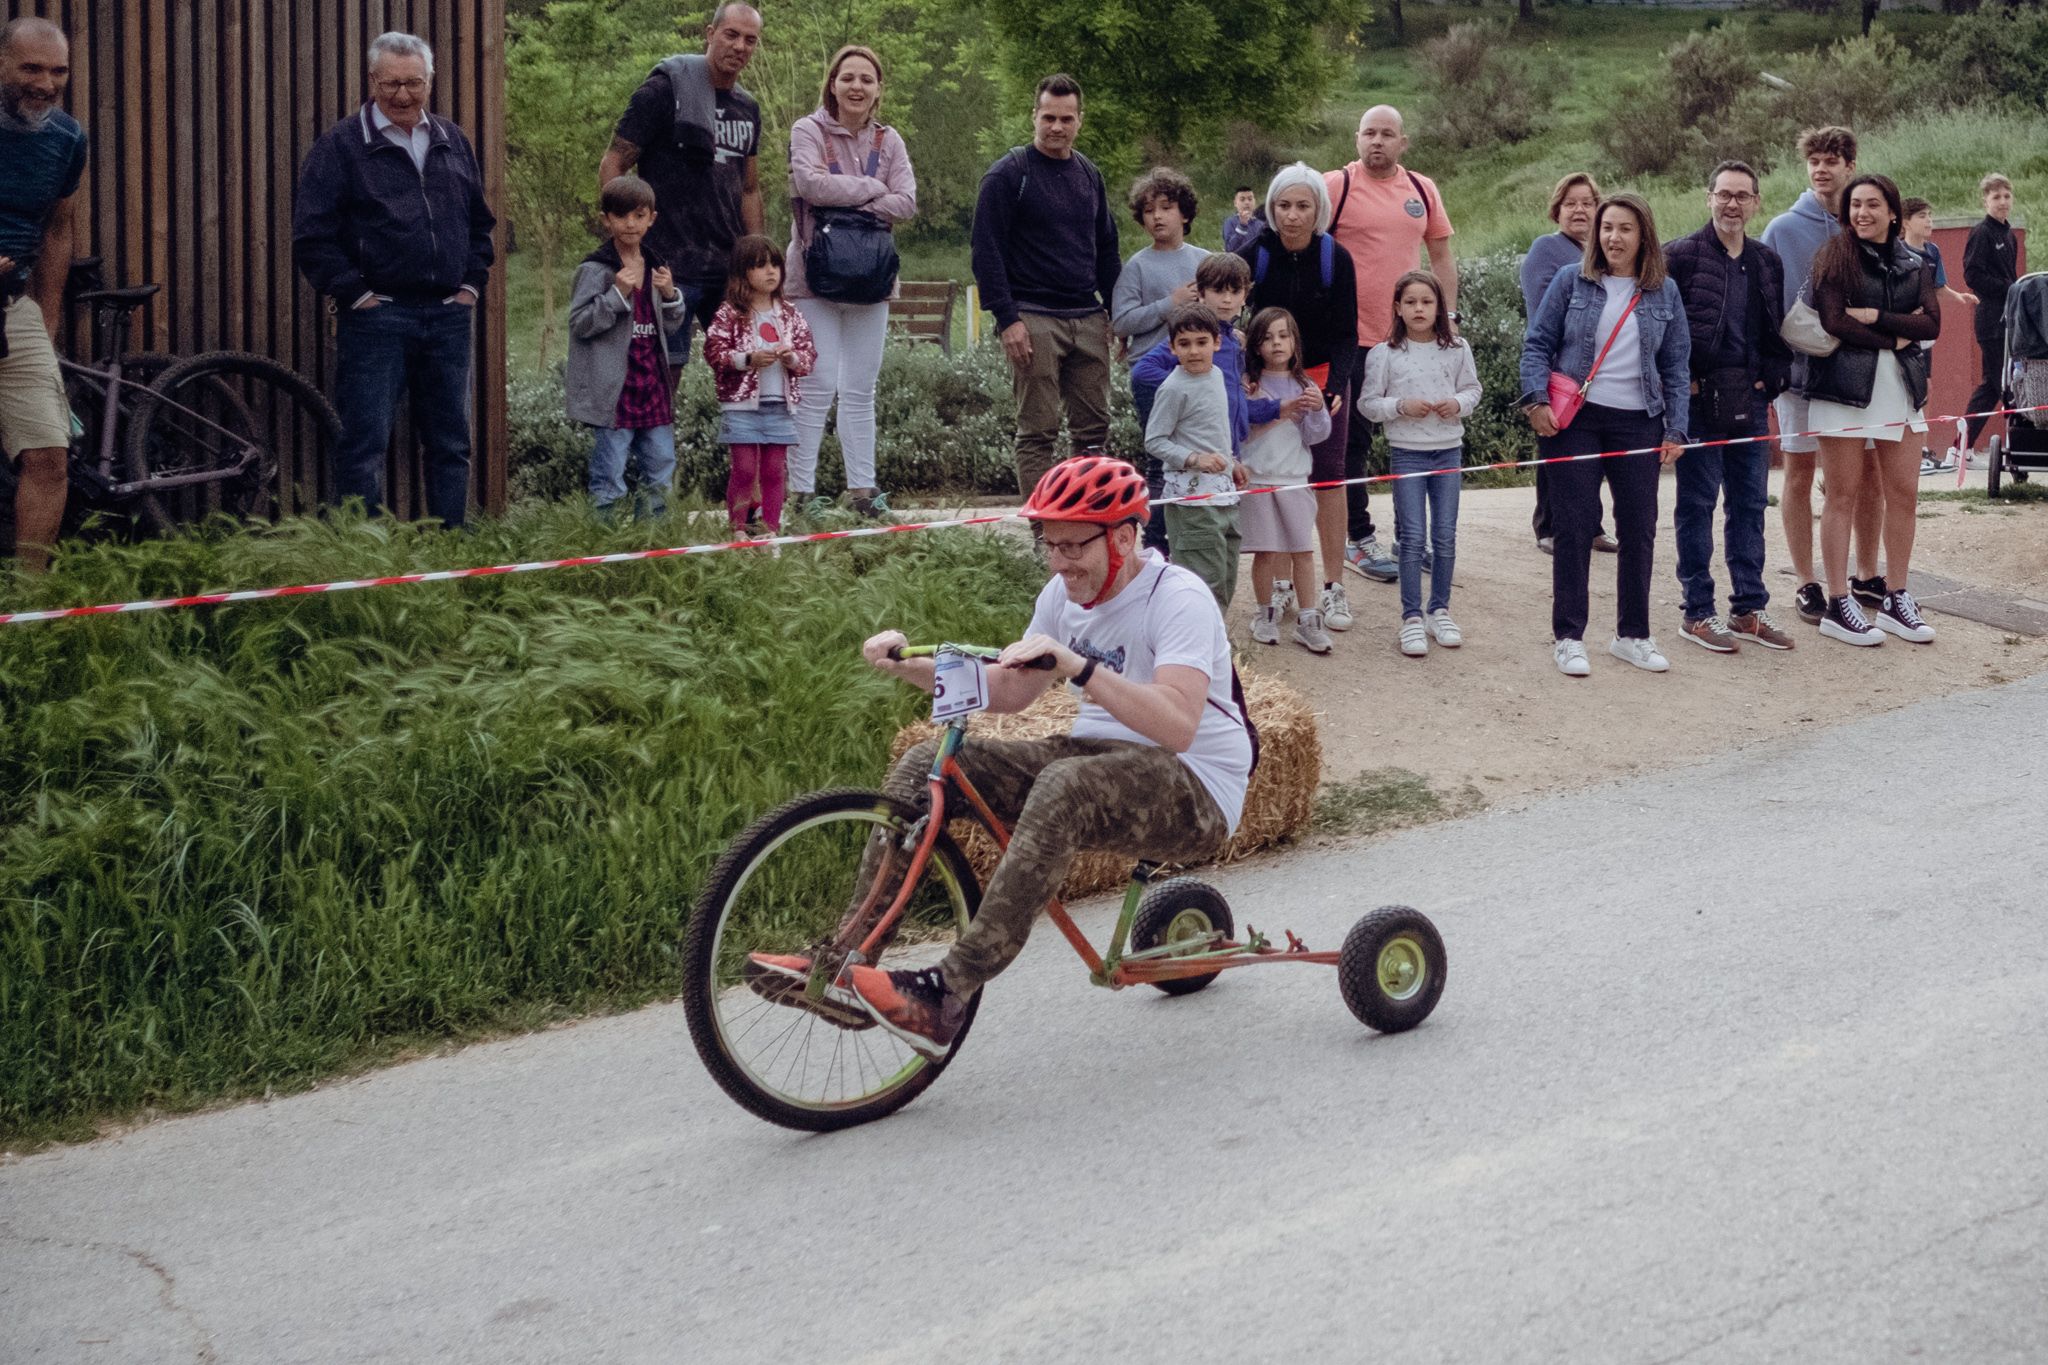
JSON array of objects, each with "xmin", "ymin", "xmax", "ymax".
[{"xmin": 1028, "ymin": 551, "xmax": 1251, "ymax": 833}]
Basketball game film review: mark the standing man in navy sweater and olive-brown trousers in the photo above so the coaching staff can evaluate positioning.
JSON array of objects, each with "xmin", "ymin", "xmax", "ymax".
[{"xmin": 973, "ymin": 76, "xmax": 1122, "ymax": 501}]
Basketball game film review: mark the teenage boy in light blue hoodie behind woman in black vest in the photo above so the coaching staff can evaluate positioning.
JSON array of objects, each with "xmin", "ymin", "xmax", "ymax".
[{"xmin": 1763, "ymin": 127, "xmax": 1884, "ymax": 626}]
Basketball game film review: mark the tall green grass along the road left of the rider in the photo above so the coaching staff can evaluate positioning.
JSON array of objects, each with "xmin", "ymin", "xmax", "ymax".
[{"xmin": 0, "ymin": 505, "xmax": 1038, "ymax": 1138}]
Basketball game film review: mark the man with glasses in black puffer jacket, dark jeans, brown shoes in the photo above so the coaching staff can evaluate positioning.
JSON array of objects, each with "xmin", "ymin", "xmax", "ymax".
[{"xmin": 1665, "ymin": 162, "xmax": 1792, "ymax": 655}]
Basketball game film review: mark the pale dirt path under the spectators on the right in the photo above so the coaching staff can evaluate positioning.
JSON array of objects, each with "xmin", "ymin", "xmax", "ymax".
[{"xmin": 1231, "ymin": 475, "xmax": 2048, "ymax": 806}]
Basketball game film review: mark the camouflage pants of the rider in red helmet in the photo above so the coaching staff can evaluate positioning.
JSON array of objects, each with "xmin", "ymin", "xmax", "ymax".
[{"xmin": 883, "ymin": 735, "xmax": 1229, "ymax": 995}]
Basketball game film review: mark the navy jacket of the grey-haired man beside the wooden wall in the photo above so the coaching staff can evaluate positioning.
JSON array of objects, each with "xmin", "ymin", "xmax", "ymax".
[{"xmin": 291, "ymin": 104, "xmax": 498, "ymax": 309}]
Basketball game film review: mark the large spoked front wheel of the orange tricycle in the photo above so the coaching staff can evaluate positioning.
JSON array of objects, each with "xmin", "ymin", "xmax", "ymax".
[{"xmin": 682, "ymin": 790, "xmax": 981, "ymax": 1132}]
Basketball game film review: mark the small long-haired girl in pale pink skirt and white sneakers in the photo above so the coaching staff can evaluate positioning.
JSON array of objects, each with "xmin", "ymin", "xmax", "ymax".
[{"xmin": 1237, "ymin": 309, "xmax": 1341, "ymax": 655}]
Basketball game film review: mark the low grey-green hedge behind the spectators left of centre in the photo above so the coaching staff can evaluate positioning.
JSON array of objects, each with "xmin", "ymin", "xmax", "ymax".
[{"xmin": 506, "ymin": 342, "xmax": 1145, "ymax": 501}]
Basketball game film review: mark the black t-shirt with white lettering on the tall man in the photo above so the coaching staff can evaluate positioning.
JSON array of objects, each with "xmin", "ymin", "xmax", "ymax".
[{"xmin": 618, "ymin": 72, "xmax": 762, "ymax": 284}]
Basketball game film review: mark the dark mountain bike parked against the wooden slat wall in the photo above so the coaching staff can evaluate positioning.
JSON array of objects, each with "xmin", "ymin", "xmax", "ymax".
[{"xmin": 0, "ymin": 256, "xmax": 342, "ymax": 532}]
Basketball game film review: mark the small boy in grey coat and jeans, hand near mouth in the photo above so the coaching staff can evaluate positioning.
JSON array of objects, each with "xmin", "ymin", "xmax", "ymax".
[{"xmin": 565, "ymin": 176, "xmax": 686, "ymax": 520}]
